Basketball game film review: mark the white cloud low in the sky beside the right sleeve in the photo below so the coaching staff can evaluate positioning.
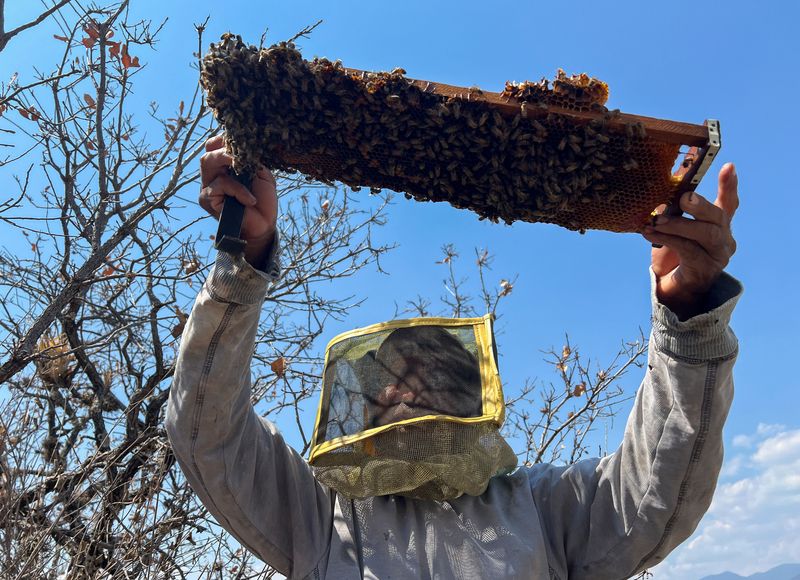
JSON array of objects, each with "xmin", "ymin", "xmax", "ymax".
[{"xmin": 651, "ymin": 424, "xmax": 800, "ymax": 580}]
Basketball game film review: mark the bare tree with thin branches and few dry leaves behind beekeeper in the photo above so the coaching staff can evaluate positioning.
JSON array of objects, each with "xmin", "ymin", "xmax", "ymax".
[{"xmin": 0, "ymin": 0, "xmax": 644, "ymax": 579}]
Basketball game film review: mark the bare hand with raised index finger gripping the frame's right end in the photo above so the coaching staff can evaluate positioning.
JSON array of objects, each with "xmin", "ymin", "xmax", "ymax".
[{"xmin": 642, "ymin": 163, "xmax": 739, "ymax": 320}]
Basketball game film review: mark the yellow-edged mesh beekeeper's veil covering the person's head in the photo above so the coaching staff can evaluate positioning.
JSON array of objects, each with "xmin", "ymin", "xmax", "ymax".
[{"xmin": 309, "ymin": 316, "xmax": 517, "ymax": 500}]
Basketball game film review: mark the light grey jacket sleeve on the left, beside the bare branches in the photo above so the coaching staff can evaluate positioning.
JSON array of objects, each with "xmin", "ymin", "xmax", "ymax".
[{"xmin": 166, "ymin": 244, "xmax": 332, "ymax": 577}]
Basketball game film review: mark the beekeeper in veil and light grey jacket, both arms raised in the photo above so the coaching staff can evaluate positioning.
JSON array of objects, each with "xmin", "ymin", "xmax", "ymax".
[{"xmin": 166, "ymin": 137, "xmax": 741, "ymax": 580}]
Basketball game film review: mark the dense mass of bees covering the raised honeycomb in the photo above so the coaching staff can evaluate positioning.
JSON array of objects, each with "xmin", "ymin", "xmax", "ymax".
[{"xmin": 201, "ymin": 34, "xmax": 678, "ymax": 231}]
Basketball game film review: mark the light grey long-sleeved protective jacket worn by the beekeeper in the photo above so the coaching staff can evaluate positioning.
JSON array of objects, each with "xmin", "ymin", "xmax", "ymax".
[{"xmin": 166, "ymin": 246, "xmax": 741, "ymax": 580}]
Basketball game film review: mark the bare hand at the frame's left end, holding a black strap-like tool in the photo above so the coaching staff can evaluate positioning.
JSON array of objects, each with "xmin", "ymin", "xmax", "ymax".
[{"xmin": 198, "ymin": 135, "xmax": 278, "ymax": 267}]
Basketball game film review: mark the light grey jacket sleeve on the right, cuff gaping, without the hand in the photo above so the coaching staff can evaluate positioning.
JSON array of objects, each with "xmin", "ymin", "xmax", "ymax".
[{"xmin": 528, "ymin": 272, "xmax": 742, "ymax": 580}]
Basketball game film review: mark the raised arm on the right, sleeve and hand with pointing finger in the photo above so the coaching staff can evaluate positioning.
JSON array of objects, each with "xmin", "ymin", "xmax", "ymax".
[{"xmin": 529, "ymin": 164, "xmax": 741, "ymax": 580}]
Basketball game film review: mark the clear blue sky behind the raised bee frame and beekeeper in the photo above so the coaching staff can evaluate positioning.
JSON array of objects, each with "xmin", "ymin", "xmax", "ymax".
[{"xmin": 0, "ymin": 0, "xmax": 800, "ymax": 580}]
